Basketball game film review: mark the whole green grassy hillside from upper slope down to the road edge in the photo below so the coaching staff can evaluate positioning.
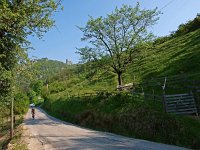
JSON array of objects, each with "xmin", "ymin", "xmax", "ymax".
[{"xmin": 43, "ymin": 30, "xmax": 200, "ymax": 149}]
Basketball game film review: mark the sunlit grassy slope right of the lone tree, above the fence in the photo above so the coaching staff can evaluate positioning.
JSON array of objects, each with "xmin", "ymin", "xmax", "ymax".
[{"xmin": 128, "ymin": 27, "xmax": 200, "ymax": 80}]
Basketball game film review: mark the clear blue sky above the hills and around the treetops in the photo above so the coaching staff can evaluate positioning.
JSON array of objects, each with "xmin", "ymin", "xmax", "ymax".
[{"xmin": 29, "ymin": 0, "xmax": 200, "ymax": 63}]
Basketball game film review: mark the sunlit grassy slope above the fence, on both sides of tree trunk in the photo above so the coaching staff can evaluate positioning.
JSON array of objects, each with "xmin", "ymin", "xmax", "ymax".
[{"xmin": 46, "ymin": 30, "xmax": 200, "ymax": 95}]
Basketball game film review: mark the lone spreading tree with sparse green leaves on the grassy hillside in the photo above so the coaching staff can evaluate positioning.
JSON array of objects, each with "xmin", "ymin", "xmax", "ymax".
[{"xmin": 78, "ymin": 3, "xmax": 159, "ymax": 85}]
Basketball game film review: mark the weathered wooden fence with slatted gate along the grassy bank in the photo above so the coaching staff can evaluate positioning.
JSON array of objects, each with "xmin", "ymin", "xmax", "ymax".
[{"xmin": 63, "ymin": 74, "xmax": 200, "ymax": 115}]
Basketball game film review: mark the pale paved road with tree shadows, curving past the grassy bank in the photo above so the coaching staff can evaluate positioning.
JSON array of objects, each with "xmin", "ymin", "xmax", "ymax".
[{"xmin": 25, "ymin": 109, "xmax": 186, "ymax": 150}]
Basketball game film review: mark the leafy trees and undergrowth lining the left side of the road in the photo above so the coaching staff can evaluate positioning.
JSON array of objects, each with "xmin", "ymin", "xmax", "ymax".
[{"xmin": 0, "ymin": 0, "xmax": 60, "ymax": 149}]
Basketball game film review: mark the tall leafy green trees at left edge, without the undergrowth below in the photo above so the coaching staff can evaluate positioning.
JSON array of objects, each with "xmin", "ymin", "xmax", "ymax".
[{"xmin": 0, "ymin": 0, "xmax": 60, "ymax": 138}]
